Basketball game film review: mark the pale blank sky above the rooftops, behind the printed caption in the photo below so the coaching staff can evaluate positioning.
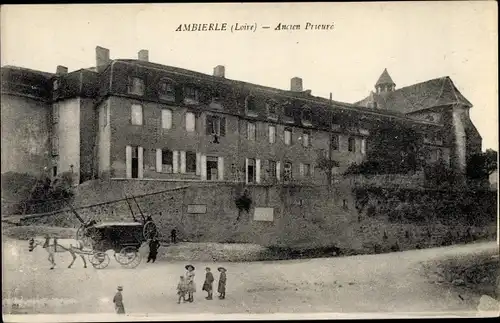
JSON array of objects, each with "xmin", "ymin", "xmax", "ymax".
[{"xmin": 1, "ymin": 1, "xmax": 498, "ymax": 150}]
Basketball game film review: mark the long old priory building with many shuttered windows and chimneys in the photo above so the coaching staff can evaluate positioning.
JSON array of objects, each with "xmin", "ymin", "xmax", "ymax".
[{"xmin": 2, "ymin": 47, "xmax": 481, "ymax": 184}]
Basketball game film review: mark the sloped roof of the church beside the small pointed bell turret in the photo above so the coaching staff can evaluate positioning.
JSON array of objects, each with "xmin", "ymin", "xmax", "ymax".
[{"xmin": 354, "ymin": 76, "xmax": 472, "ymax": 114}]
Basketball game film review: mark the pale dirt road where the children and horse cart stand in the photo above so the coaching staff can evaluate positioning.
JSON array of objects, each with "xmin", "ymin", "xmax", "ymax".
[{"xmin": 2, "ymin": 239, "xmax": 498, "ymax": 314}]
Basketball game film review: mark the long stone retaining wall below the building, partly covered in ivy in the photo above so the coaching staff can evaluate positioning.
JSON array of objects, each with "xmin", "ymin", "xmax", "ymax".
[{"xmin": 19, "ymin": 180, "xmax": 496, "ymax": 253}]
